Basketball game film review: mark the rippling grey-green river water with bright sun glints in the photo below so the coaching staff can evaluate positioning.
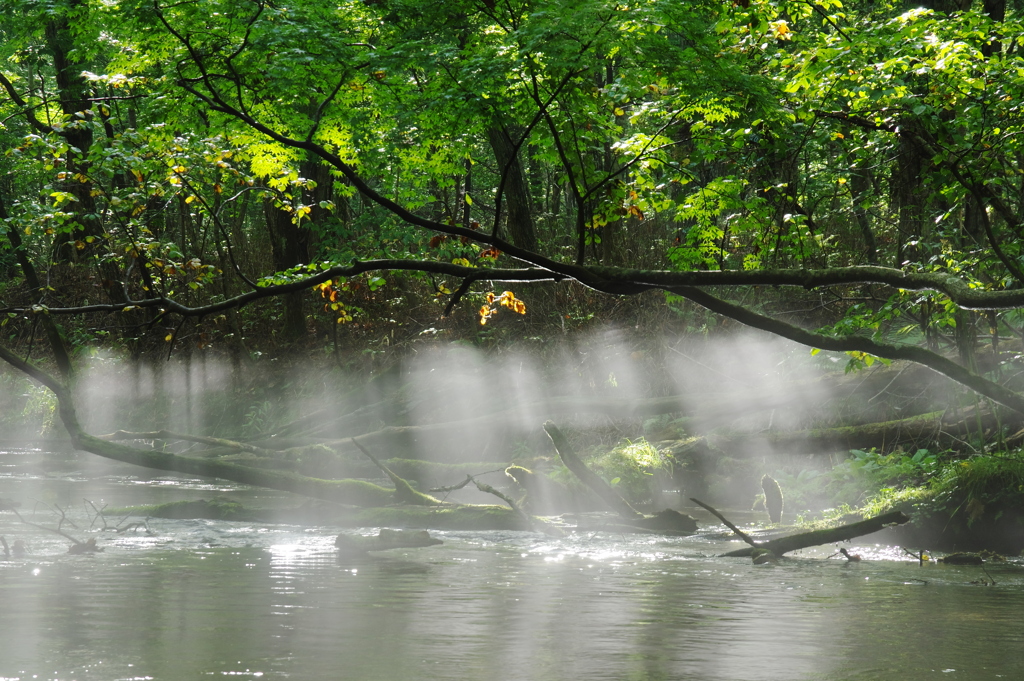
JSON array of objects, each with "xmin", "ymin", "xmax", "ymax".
[{"xmin": 0, "ymin": 452, "xmax": 1024, "ymax": 681}]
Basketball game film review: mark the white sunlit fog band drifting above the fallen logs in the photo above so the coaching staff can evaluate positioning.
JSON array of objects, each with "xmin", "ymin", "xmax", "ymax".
[{"xmin": 4, "ymin": 321, "xmax": 948, "ymax": 507}]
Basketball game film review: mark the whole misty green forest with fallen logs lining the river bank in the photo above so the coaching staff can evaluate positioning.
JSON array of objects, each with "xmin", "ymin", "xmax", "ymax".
[{"xmin": 0, "ymin": 0, "xmax": 1024, "ymax": 554}]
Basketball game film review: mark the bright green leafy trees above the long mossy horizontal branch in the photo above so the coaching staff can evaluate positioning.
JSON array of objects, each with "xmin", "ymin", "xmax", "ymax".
[{"xmin": 2, "ymin": 0, "xmax": 1024, "ymax": 491}]
